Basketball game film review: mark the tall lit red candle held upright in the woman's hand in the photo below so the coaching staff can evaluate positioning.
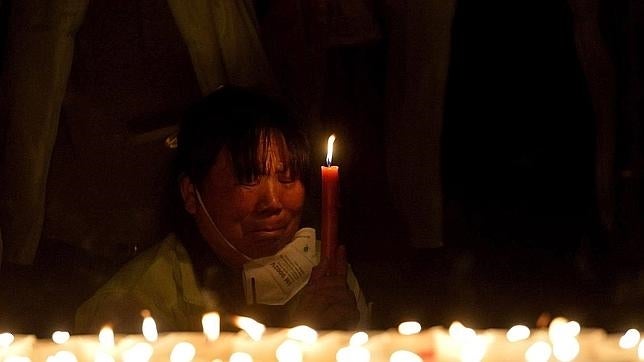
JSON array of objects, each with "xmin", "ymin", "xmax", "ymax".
[{"xmin": 321, "ymin": 135, "xmax": 339, "ymax": 260}]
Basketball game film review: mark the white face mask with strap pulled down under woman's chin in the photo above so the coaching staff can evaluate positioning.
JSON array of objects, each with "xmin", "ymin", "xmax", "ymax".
[{"xmin": 195, "ymin": 187, "xmax": 320, "ymax": 305}]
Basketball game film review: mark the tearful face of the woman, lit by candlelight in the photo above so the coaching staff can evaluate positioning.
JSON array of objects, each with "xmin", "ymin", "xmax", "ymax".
[{"xmin": 189, "ymin": 135, "xmax": 304, "ymax": 267}]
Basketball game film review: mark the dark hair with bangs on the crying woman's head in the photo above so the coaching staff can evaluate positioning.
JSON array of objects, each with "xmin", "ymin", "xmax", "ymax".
[{"xmin": 177, "ymin": 87, "xmax": 309, "ymax": 187}]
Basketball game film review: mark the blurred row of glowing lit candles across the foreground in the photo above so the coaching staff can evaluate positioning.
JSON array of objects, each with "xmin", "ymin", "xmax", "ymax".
[{"xmin": 0, "ymin": 313, "xmax": 644, "ymax": 362}]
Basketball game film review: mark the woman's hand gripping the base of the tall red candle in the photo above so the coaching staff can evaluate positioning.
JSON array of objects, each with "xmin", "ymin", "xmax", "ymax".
[{"xmin": 291, "ymin": 246, "xmax": 360, "ymax": 329}]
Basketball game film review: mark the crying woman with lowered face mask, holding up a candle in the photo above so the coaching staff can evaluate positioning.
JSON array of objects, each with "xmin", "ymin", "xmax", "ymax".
[{"xmin": 76, "ymin": 88, "xmax": 366, "ymax": 332}]
